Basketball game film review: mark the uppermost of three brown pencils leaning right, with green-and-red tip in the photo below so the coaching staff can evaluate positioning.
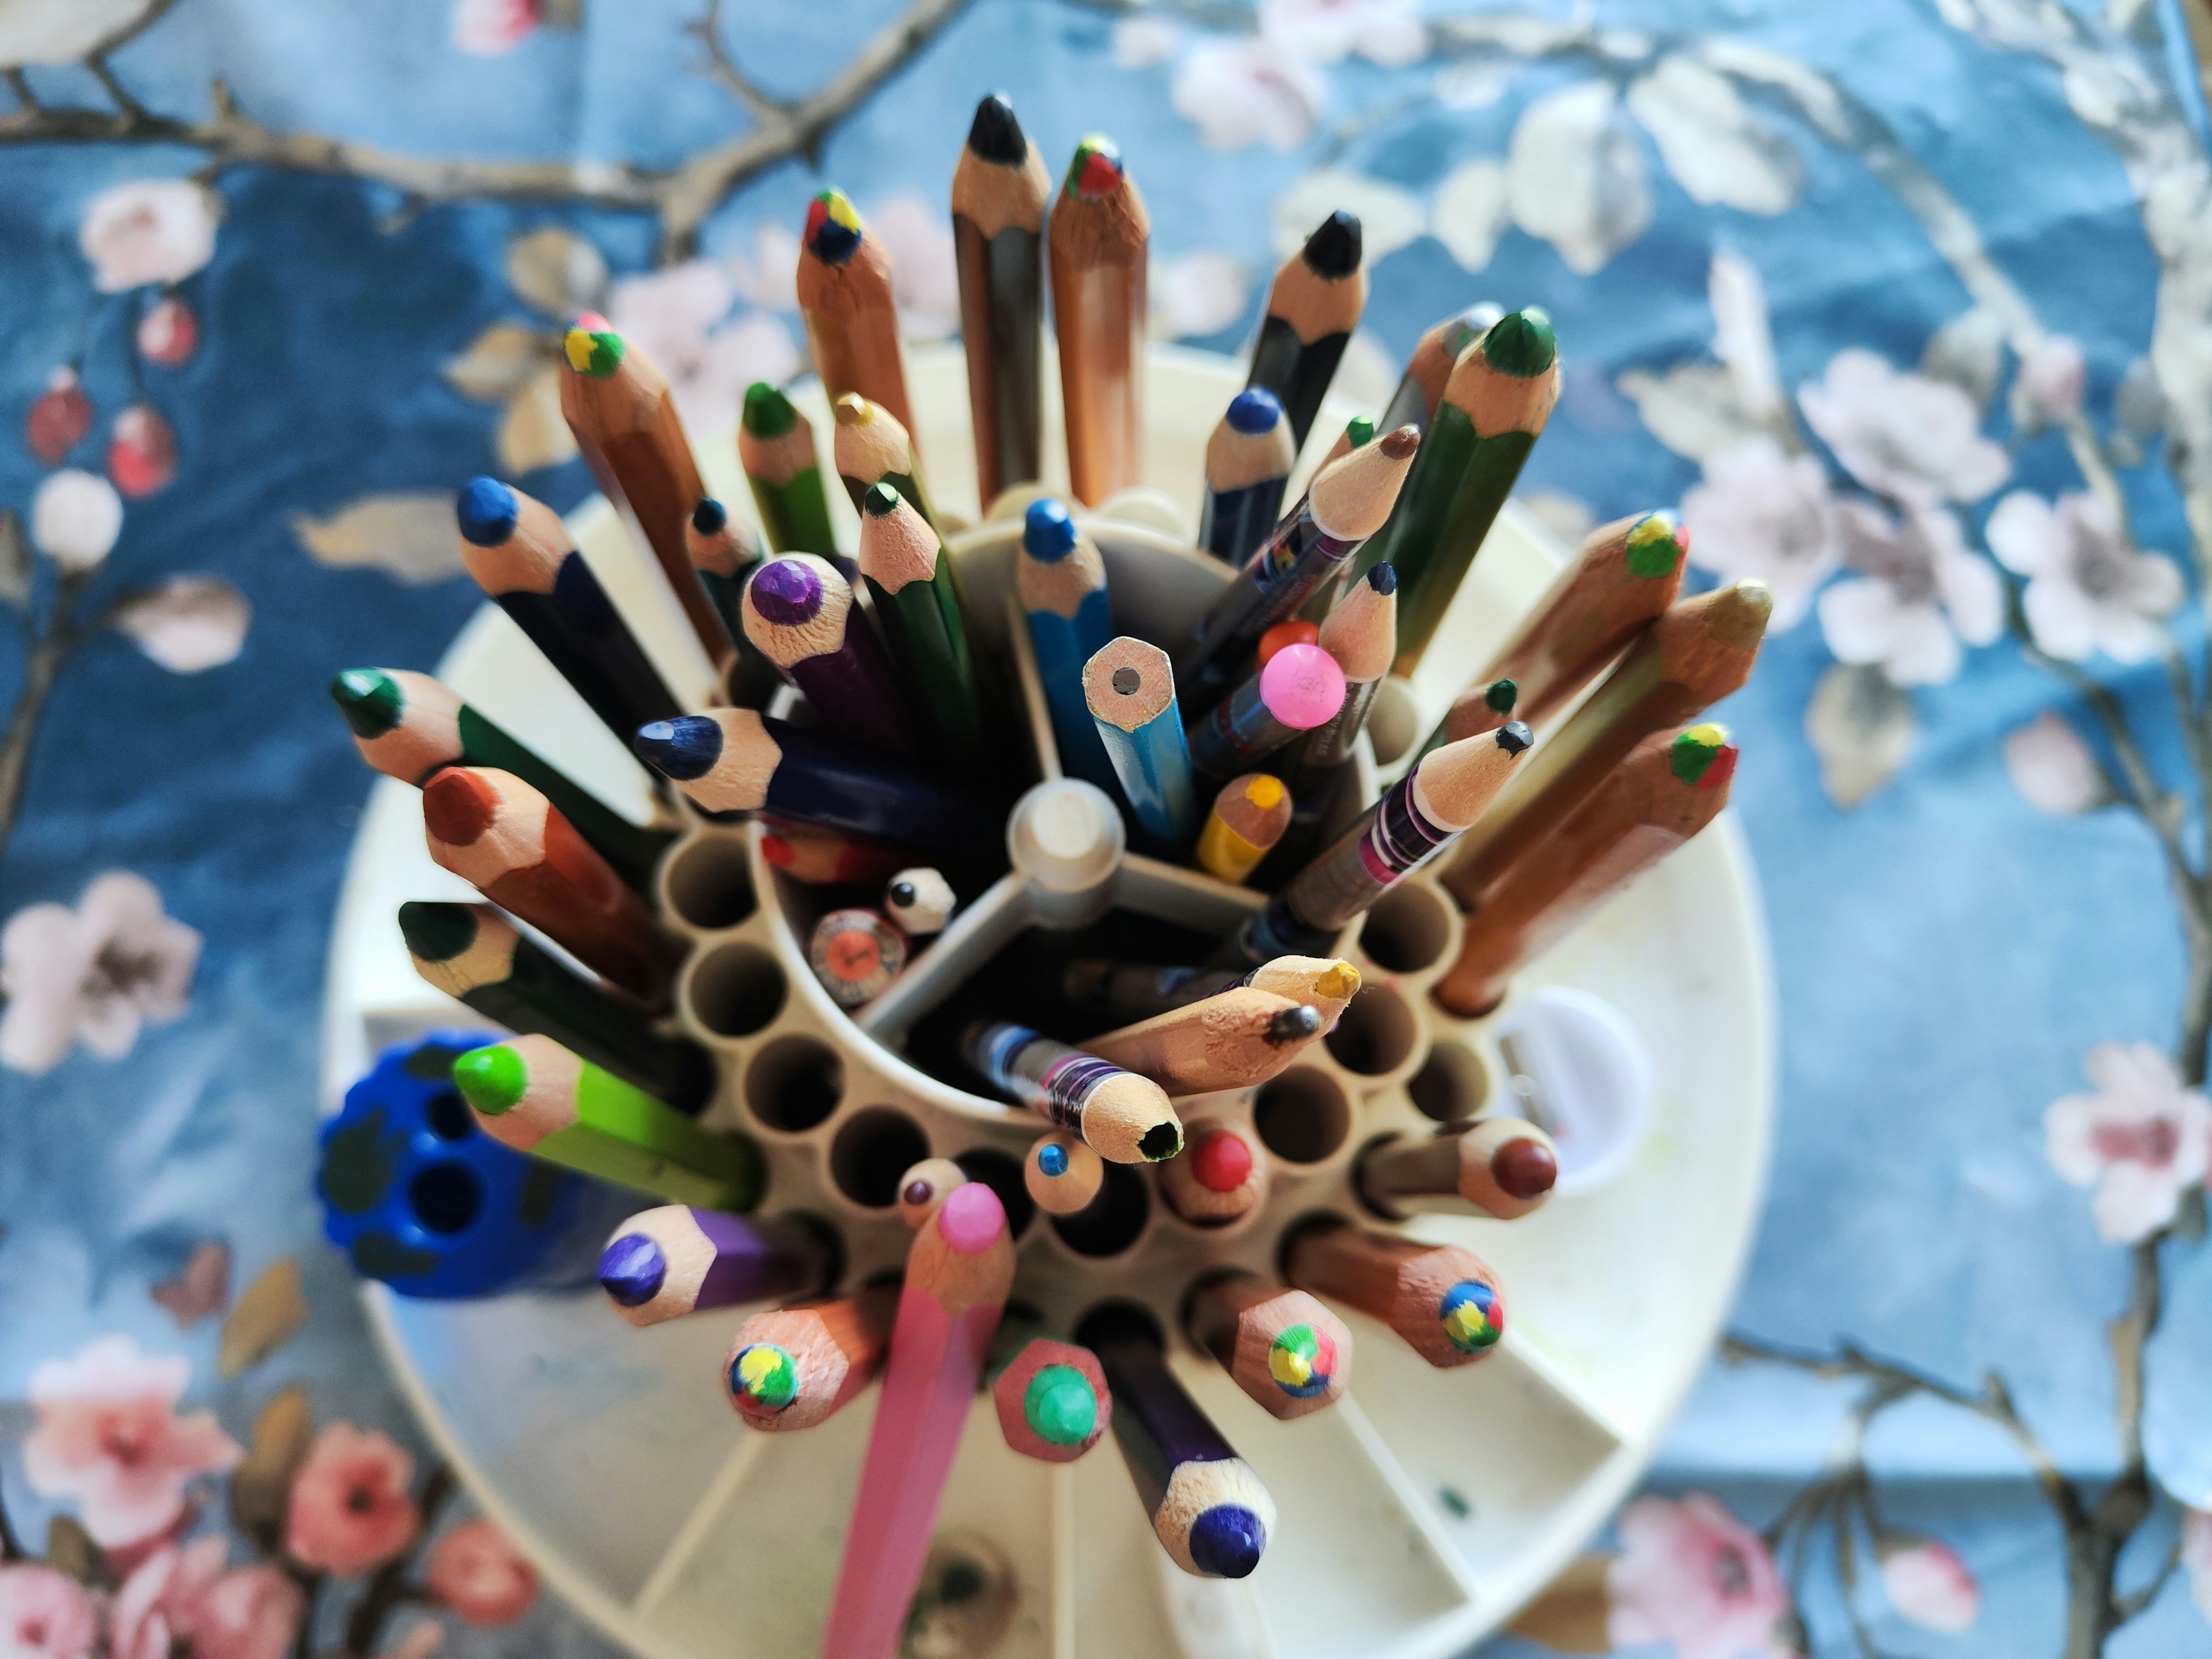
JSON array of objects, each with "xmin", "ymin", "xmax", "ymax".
[{"xmin": 1445, "ymin": 513, "xmax": 1690, "ymax": 737}]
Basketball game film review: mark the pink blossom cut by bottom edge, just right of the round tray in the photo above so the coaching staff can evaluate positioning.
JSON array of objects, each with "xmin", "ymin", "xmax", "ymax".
[{"xmin": 1606, "ymin": 1493, "xmax": 1790, "ymax": 1659}]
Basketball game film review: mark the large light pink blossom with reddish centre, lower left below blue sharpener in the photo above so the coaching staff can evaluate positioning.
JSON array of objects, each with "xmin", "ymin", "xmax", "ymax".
[{"xmin": 22, "ymin": 1336, "xmax": 243, "ymax": 1548}]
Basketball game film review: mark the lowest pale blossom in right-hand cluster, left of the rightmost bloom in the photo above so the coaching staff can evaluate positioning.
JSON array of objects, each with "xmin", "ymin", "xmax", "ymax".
[{"xmin": 1813, "ymin": 502, "xmax": 2004, "ymax": 685}]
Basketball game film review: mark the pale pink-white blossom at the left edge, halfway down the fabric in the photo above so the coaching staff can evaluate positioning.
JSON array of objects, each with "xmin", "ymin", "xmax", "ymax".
[{"xmin": 0, "ymin": 869, "xmax": 199, "ymax": 1079}]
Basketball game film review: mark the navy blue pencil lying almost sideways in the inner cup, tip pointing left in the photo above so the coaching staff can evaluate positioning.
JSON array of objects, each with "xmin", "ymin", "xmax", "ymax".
[{"xmin": 632, "ymin": 708, "xmax": 1004, "ymax": 854}]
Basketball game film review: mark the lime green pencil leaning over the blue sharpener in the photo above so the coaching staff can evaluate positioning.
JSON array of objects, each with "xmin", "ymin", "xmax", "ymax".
[{"xmin": 453, "ymin": 1037, "xmax": 766, "ymax": 1210}]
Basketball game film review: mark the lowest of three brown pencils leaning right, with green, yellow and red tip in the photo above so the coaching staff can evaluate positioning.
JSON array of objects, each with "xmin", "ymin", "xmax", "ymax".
[{"xmin": 1435, "ymin": 724, "xmax": 1736, "ymax": 1013}]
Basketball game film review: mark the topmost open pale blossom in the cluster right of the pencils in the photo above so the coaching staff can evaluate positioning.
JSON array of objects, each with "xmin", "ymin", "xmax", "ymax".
[{"xmin": 1798, "ymin": 345, "xmax": 2013, "ymax": 506}]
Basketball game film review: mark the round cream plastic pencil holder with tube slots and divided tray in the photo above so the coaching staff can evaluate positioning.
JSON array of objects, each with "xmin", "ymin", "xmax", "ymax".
[{"xmin": 323, "ymin": 347, "xmax": 1774, "ymax": 1659}]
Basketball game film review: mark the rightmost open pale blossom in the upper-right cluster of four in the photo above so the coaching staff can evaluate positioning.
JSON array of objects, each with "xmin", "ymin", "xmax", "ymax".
[{"xmin": 1984, "ymin": 489, "xmax": 2186, "ymax": 664}]
